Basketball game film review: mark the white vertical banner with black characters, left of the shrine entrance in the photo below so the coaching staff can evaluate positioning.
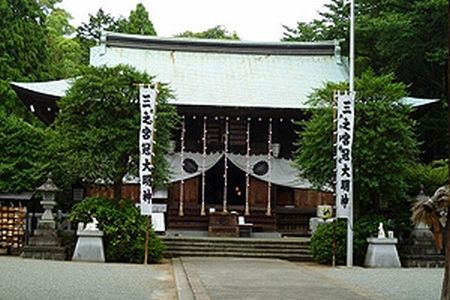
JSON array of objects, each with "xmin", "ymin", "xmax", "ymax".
[{"xmin": 139, "ymin": 85, "xmax": 158, "ymax": 216}]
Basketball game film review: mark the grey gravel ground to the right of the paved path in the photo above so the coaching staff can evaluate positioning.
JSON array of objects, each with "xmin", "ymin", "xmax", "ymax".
[{"xmin": 301, "ymin": 265, "xmax": 444, "ymax": 300}]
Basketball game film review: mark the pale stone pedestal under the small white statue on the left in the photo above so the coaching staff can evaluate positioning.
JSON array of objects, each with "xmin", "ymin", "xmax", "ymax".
[{"xmin": 72, "ymin": 230, "xmax": 105, "ymax": 262}]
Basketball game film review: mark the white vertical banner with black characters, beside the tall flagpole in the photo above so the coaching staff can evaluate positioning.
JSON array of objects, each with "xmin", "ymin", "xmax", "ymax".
[{"xmin": 336, "ymin": 93, "xmax": 355, "ymax": 219}]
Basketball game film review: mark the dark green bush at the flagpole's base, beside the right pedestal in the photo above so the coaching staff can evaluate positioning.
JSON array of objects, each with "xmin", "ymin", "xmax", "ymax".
[{"xmin": 311, "ymin": 215, "xmax": 393, "ymax": 265}]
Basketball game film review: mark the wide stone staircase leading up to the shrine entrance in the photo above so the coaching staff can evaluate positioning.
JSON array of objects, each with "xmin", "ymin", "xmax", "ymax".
[{"xmin": 161, "ymin": 236, "xmax": 311, "ymax": 261}]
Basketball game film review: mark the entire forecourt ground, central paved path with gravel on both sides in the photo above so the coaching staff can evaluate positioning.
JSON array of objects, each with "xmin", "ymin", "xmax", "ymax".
[{"xmin": 0, "ymin": 256, "xmax": 443, "ymax": 300}]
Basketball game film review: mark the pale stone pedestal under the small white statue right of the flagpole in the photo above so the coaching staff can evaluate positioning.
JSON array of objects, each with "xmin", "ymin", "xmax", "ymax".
[{"xmin": 364, "ymin": 238, "xmax": 401, "ymax": 268}]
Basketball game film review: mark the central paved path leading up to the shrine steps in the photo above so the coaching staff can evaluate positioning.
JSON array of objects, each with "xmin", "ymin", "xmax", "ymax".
[{"xmin": 181, "ymin": 257, "xmax": 383, "ymax": 300}]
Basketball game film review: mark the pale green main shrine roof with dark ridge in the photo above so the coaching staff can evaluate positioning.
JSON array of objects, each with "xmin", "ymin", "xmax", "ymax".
[{"xmin": 91, "ymin": 33, "xmax": 348, "ymax": 108}]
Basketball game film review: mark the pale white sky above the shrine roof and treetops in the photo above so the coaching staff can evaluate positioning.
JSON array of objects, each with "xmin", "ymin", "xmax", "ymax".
[{"xmin": 59, "ymin": 0, "xmax": 330, "ymax": 41}]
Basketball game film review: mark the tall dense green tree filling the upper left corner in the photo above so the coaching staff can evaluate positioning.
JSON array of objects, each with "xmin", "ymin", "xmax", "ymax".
[{"xmin": 0, "ymin": 0, "xmax": 48, "ymax": 115}]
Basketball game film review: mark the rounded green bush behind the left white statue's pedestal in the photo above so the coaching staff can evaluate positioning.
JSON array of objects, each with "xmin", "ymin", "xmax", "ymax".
[{"xmin": 69, "ymin": 197, "xmax": 165, "ymax": 263}]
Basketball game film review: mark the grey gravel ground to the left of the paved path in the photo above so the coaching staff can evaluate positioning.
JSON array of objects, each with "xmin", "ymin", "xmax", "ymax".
[{"xmin": 0, "ymin": 256, "xmax": 177, "ymax": 300}]
